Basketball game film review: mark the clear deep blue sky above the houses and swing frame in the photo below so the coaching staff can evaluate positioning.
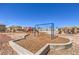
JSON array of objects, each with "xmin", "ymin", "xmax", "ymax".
[{"xmin": 0, "ymin": 3, "xmax": 79, "ymax": 27}]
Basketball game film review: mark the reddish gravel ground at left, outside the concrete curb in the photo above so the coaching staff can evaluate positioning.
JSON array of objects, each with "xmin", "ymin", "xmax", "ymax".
[{"xmin": 0, "ymin": 34, "xmax": 17, "ymax": 55}]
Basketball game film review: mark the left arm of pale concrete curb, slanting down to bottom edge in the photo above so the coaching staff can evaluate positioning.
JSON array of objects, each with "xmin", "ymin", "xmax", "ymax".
[{"xmin": 9, "ymin": 41, "xmax": 33, "ymax": 55}]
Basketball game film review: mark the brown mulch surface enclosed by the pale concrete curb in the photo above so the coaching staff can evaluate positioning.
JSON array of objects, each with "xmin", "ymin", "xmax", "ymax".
[{"xmin": 16, "ymin": 33, "xmax": 69, "ymax": 53}]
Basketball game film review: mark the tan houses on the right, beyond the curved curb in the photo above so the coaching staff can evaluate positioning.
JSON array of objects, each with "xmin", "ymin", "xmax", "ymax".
[{"xmin": 58, "ymin": 27, "xmax": 79, "ymax": 34}]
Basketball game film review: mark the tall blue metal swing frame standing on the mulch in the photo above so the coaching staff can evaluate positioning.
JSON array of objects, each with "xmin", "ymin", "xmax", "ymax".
[{"xmin": 34, "ymin": 23, "xmax": 54, "ymax": 39}]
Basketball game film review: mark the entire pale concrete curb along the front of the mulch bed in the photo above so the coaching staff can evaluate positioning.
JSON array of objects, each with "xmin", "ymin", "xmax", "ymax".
[{"xmin": 9, "ymin": 38, "xmax": 72, "ymax": 55}]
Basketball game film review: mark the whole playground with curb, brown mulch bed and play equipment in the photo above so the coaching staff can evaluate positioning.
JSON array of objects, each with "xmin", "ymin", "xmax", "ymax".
[{"xmin": 9, "ymin": 23, "xmax": 72, "ymax": 54}]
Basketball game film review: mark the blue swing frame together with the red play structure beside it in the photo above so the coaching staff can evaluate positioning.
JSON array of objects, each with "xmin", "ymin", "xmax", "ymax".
[{"xmin": 25, "ymin": 23, "xmax": 54, "ymax": 39}]
